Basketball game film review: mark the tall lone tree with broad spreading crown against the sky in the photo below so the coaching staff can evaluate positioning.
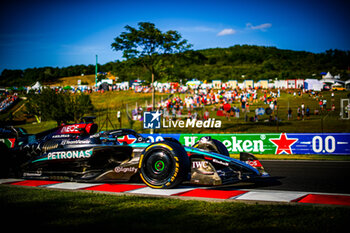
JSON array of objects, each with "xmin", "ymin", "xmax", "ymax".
[{"xmin": 111, "ymin": 22, "xmax": 192, "ymax": 108}]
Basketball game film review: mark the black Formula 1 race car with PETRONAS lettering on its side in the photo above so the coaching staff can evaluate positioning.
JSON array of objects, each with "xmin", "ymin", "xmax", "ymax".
[{"xmin": 2, "ymin": 119, "xmax": 269, "ymax": 188}]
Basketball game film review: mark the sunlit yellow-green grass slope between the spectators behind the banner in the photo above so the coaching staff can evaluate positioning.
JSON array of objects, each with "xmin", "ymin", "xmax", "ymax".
[{"xmin": 14, "ymin": 88, "xmax": 350, "ymax": 133}]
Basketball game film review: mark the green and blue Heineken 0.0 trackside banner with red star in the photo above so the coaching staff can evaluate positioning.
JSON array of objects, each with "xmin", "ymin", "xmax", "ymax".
[{"xmin": 143, "ymin": 133, "xmax": 350, "ymax": 155}]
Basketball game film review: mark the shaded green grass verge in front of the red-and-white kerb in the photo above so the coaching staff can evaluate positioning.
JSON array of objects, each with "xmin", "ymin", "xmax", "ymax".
[{"xmin": 0, "ymin": 185, "xmax": 350, "ymax": 232}]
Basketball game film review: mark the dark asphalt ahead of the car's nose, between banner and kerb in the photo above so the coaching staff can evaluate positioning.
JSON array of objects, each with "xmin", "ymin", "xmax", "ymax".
[{"xmin": 227, "ymin": 160, "xmax": 350, "ymax": 194}]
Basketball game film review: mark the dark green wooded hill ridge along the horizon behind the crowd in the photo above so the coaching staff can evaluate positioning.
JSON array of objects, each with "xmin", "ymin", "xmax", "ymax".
[{"xmin": 0, "ymin": 45, "xmax": 350, "ymax": 86}]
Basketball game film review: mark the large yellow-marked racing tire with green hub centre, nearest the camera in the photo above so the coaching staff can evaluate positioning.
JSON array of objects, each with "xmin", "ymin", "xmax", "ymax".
[{"xmin": 139, "ymin": 141, "xmax": 190, "ymax": 189}]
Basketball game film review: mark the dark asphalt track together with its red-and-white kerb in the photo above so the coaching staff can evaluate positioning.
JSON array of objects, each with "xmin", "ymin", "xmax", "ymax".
[{"xmin": 0, "ymin": 160, "xmax": 350, "ymax": 206}]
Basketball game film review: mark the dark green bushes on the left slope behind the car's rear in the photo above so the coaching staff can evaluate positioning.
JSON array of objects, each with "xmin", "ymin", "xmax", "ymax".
[{"xmin": 26, "ymin": 88, "xmax": 93, "ymax": 125}]
